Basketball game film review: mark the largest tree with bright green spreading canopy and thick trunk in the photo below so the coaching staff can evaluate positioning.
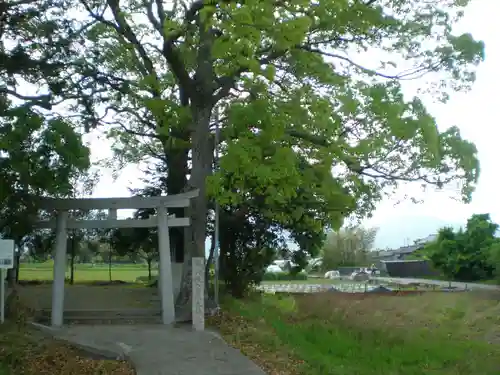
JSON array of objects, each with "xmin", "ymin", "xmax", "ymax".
[{"xmin": 15, "ymin": 0, "xmax": 483, "ymax": 318}]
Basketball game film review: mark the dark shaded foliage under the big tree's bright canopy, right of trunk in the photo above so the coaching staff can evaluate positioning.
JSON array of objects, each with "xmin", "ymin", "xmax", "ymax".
[{"xmin": 215, "ymin": 163, "xmax": 331, "ymax": 296}]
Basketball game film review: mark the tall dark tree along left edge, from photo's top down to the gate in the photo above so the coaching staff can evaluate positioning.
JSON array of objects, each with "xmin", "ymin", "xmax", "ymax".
[{"xmin": 0, "ymin": 0, "xmax": 90, "ymax": 280}]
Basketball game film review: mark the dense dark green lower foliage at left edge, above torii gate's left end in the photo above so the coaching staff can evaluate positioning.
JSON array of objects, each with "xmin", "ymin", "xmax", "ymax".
[{"xmin": 0, "ymin": 98, "xmax": 90, "ymax": 245}]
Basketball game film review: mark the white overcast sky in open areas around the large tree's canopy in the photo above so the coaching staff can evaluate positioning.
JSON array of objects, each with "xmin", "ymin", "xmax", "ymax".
[{"xmin": 88, "ymin": 0, "xmax": 500, "ymax": 248}]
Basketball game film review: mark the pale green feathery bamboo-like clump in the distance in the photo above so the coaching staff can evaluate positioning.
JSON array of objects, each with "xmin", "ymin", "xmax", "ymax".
[{"xmin": 321, "ymin": 226, "xmax": 378, "ymax": 271}]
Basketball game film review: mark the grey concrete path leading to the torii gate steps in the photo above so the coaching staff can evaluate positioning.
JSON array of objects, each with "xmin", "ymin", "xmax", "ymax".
[{"xmin": 34, "ymin": 325, "xmax": 265, "ymax": 375}]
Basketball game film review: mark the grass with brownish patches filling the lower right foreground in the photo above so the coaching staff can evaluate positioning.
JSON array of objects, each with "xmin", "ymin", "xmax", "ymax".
[{"xmin": 212, "ymin": 293, "xmax": 500, "ymax": 375}]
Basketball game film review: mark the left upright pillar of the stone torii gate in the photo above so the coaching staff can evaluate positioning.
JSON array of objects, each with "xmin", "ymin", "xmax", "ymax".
[{"xmin": 51, "ymin": 211, "xmax": 68, "ymax": 327}]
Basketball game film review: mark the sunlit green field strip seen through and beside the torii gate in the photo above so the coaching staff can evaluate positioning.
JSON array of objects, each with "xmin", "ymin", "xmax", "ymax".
[{"xmin": 19, "ymin": 263, "xmax": 157, "ymax": 282}]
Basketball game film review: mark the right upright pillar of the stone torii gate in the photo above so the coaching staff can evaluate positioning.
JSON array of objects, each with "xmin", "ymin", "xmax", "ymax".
[{"xmin": 158, "ymin": 207, "xmax": 175, "ymax": 324}]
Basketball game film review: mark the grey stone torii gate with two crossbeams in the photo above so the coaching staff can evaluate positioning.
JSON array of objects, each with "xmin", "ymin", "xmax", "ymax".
[{"xmin": 36, "ymin": 190, "xmax": 199, "ymax": 327}]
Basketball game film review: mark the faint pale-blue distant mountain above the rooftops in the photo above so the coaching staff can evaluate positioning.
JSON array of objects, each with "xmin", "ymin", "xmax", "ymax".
[{"xmin": 375, "ymin": 216, "xmax": 465, "ymax": 249}]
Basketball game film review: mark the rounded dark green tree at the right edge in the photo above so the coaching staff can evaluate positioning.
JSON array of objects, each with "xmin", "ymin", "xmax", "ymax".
[{"xmin": 424, "ymin": 214, "xmax": 500, "ymax": 281}]
